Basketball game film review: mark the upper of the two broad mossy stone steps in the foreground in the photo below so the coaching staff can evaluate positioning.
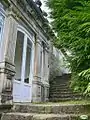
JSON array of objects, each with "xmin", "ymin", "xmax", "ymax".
[{"xmin": 12, "ymin": 103, "xmax": 90, "ymax": 114}]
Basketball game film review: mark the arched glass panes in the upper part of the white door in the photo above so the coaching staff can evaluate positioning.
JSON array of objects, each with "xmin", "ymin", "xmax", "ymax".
[{"xmin": 14, "ymin": 29, "xmax": 32, "ymax": 84}]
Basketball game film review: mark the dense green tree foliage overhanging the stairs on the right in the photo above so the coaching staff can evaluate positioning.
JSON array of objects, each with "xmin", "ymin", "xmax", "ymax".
[{"xmin": 47, "ymin": 0, "xmax": 90, "ymax": 93}]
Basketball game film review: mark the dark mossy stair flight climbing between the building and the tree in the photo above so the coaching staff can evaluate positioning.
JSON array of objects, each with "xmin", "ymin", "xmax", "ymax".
[{"xmin": 49, "ymin": 74, "xmax": 82, "ymax": 102}]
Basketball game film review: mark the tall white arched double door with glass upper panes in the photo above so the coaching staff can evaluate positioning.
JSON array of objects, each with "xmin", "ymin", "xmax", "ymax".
[{"xmin": 13, "ymin": 27, "xmax": 34, "ymax": 102}]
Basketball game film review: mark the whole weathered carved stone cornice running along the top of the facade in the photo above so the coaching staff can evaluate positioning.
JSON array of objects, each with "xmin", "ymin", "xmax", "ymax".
[{"xmin": 0, "ymin": 0, "xmax": 54, "ymax": 40}]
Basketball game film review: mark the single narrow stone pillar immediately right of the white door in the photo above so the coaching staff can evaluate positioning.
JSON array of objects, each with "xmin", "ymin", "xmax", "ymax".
[{"xmin": 32, "ymin": 35, "xmax": 42, "ymax": 102}]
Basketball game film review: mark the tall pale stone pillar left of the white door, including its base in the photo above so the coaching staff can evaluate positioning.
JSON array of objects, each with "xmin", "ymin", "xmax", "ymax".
[{"xmin": 0, "ymin": 14, "xmax": 17, "ymax": 104}]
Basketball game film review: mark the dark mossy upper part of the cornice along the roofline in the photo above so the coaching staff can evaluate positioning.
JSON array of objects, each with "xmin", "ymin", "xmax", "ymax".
[{"xmin": 10, "ymin": 0, "xmax": 54, "ymax": 40}]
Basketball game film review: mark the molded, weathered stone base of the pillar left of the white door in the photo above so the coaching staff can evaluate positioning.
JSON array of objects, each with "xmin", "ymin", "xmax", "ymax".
[{"xmin": 0, "ymin": 62, "xmax": 15, "ymax": 104}]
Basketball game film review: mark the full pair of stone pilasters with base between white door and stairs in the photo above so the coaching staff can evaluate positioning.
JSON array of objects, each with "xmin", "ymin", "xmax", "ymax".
[{"xmin": 32, "ymin": 34, "xmax": 49, "ymax": 102}]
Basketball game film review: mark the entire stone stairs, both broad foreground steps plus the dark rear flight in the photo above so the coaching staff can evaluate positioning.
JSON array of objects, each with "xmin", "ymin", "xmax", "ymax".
[{"xmin": 0, "ymin": 75, "xmax": 90, "ymax": 120}]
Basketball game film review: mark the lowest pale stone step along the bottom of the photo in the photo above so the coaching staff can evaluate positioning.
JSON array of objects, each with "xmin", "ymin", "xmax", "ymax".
[{"xmin": 1, "ymin": 113, "xmax": 90, "ymax": 120}]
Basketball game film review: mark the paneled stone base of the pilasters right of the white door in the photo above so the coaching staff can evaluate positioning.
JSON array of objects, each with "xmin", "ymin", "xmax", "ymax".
[{"xmin": 32, "ymin": 76, "xmax": 49, "ymax": 102}]
